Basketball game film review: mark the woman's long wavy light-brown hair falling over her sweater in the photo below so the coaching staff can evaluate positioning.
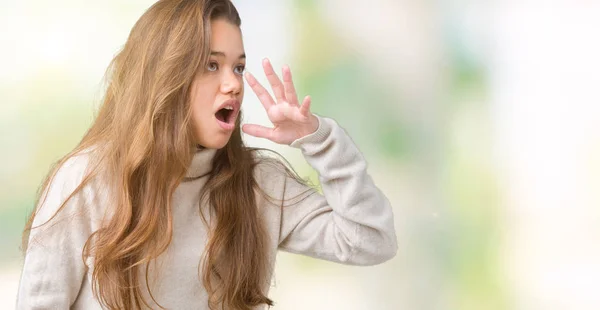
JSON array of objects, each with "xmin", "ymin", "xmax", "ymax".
[{"xmin": 22, "ymin": 0, "xmax": 314, "ymax": 309}]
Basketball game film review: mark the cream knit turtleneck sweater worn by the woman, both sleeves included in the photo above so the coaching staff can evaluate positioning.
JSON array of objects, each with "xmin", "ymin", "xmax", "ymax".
[{"xmin": 17, "ymin": 115, "xmax": 397, "ymax": 310}]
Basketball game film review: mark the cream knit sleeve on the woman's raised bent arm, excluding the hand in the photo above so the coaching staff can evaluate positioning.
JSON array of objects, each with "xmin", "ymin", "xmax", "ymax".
[{"xmin": 258, "ymin": 116, "xmax": 397, "ymax": 265}]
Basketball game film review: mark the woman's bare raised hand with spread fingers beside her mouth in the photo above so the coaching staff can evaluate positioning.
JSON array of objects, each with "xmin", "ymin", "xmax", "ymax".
[{"xmin": 242, "ymin": 58, "xmax": 319, "ymax": 145}]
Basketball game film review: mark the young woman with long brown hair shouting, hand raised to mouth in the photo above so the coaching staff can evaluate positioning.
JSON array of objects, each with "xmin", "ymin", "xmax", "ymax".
[{"xmin": 17, "ymin": 0, "xmax": 397, "ymax": 310}]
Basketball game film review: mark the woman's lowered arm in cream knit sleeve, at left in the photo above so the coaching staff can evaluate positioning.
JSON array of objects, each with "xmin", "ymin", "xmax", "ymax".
[{"xmin": 17, "ymin": 157, "xmax": 91, "ymax": 309}]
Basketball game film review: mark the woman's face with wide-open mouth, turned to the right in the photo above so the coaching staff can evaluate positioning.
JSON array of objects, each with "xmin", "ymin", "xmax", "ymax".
[{"xmin": 190, "ymin": 19, "xmax": 246, "ymax": 149}]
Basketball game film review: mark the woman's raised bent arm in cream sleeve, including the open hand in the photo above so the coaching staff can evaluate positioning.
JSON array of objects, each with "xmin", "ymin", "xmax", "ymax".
[{"xmin": 242, "ymin": 59, "xmax": 398, "ymax": 265}]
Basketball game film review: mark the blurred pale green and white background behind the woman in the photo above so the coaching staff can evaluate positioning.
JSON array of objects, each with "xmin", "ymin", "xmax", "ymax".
[{"xmin": 0, "ymin": 0, "xmax": 600, "ymax": 310}]
